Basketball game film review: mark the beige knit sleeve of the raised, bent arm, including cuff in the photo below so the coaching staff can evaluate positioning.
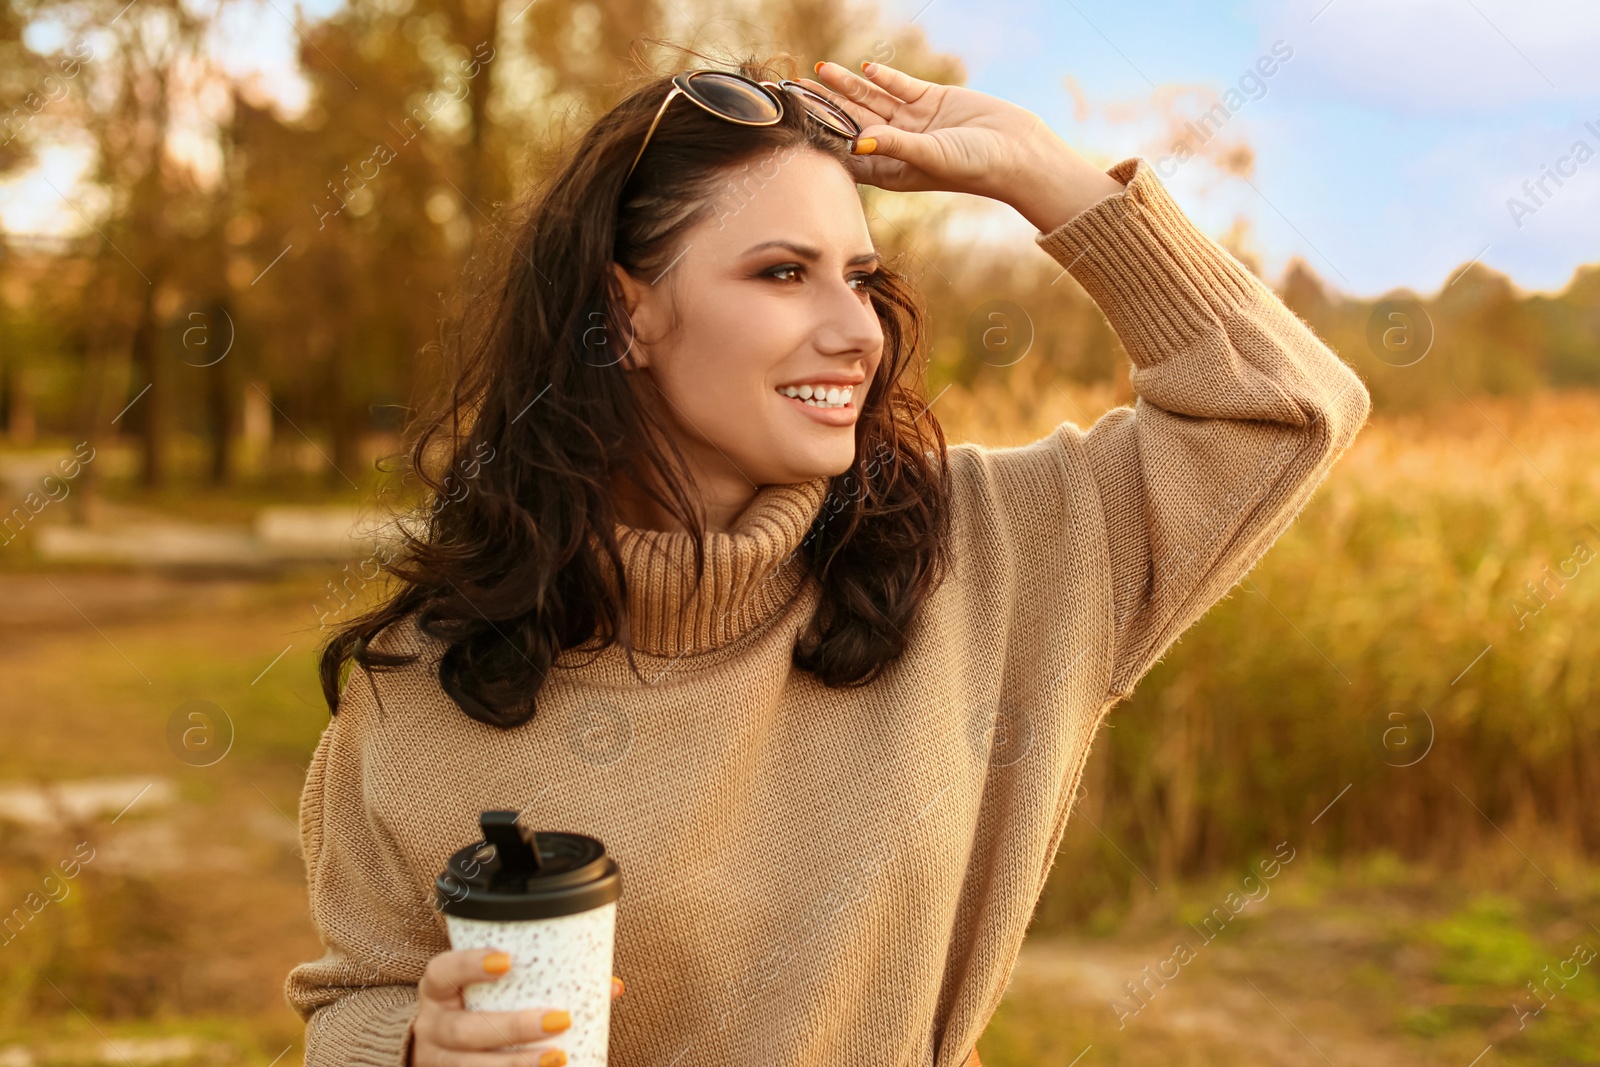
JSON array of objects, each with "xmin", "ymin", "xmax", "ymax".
[{"xmin": 1013, "ymin": 157, "xmax": 1370, "ymax": 699}]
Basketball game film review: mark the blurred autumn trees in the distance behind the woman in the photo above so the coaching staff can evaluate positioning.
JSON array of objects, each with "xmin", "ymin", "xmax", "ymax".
[{"xmin": 0, "ymin": 0, "xmax": 1600, "ymax": 507}]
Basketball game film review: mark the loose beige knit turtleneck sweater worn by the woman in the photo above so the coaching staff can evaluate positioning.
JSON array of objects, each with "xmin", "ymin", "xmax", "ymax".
[{"xmin": 286, "ymin": 157, "xmax": 1368, "ymax": 1067}]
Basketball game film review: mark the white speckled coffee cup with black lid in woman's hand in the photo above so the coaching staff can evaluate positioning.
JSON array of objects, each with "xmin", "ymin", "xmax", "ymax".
[{"xmin": 435, "ymin": 811, "xmax": 622, "ymax": 1067}]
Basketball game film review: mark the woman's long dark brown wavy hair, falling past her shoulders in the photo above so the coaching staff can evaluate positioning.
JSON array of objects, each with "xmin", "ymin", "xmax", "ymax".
[{"xmin": 318, "ymin": 53, "xmax": 950, "ymax": 728}]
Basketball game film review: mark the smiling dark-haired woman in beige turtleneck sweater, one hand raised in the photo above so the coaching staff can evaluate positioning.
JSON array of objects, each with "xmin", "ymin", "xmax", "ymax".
[{"xmin": 286, "ymin": 61, "xmax": 1368, "ymax": 1067}]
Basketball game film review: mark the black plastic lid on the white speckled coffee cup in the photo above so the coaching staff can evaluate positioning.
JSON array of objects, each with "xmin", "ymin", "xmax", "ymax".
[{"xmin": 434, "ymin": 811, "xmax": 622, "ymax": 920}]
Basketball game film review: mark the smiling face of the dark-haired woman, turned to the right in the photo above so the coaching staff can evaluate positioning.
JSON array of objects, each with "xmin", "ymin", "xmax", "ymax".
[{"xmin": 618, "ymin": 147, "xmax": 883, "ymax": 514}]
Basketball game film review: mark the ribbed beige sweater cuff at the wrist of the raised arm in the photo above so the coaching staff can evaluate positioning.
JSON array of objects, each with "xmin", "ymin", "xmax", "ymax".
[{"xmin": 1034, "ymin": 157, "xmax": 1262, "ymax": 366}]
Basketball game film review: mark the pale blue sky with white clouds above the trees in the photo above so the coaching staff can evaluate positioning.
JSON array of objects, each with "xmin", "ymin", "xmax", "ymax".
[{"xmin": 0, "ymin": 0, "xmax": 1600, "ymax": 298}]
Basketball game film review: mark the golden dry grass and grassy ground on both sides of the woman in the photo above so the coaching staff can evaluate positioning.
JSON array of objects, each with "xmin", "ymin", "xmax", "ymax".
[{"xmin": 0, "ymin": 388, "xmax": 1600, "ymax": 1067}]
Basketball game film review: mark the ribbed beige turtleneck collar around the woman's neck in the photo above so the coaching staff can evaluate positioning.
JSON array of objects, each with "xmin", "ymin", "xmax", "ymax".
[{"xmin": 598, "ymin": 475, "xmax": 832, "ymax": 656}]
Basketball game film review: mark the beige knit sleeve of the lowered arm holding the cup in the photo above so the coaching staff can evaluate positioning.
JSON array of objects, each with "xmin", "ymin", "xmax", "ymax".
[{"xmin": 285, "ymin": 667, "xmax": 448, "ymax": 1067}]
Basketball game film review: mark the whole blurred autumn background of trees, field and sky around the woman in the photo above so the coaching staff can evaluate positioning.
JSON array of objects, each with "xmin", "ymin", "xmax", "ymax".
[{"xmin": 0, "ymin": 0, "xmax": 1600, "ymax": 1067}]
